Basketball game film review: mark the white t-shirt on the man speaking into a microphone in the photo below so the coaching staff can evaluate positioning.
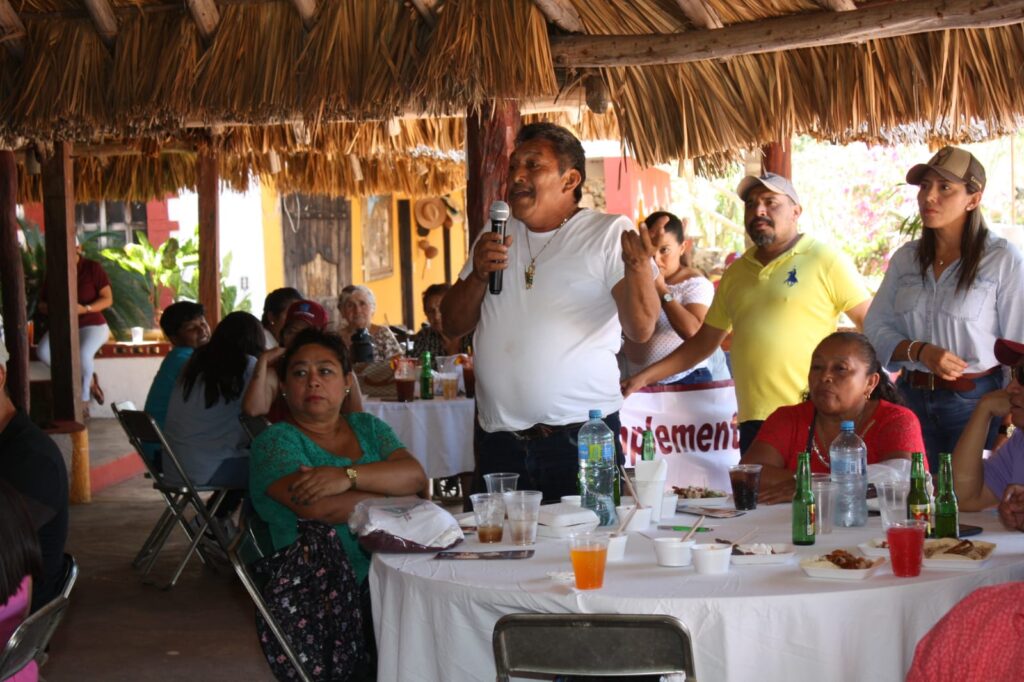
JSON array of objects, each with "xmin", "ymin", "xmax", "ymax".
[{"xmin": 459, "ymin": 209, "xmax": 633, "ymax": 432}]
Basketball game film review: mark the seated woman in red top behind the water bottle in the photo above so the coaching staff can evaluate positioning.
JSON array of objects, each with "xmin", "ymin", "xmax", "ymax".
[{"xmin": 741, "ymin": 332, "xmax": 925, "ymax": 504}]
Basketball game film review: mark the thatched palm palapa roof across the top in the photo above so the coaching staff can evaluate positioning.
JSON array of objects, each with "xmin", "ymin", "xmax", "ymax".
[{"xmin": 0, "ymin": 0, "xmax": 1024, "ymax": 199}]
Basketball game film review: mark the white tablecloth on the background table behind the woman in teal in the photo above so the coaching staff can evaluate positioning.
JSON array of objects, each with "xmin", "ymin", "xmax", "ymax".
[{"xmin": 362, "ymin": 397, "xmax": 475, "ymax": 478}]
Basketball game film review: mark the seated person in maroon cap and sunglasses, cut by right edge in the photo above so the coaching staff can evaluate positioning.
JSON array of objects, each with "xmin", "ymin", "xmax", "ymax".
[{"xmin": 953, "ymin": 339, "xmax": 1024, "ymax": 511}]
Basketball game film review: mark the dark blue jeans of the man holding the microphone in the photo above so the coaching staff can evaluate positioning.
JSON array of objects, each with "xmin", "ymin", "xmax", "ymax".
[{"xmin": 473, "ymin": 412, "xmax": 626, "ymax": 502}]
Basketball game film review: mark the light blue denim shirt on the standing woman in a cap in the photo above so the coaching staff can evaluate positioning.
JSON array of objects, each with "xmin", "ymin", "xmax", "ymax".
[{"xmin": 864, "ymin": 232, "xmax": 1024, "ymax": 374}]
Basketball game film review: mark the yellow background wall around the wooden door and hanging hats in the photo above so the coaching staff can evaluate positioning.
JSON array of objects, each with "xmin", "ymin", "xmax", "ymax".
[{"xmin": 262, "ymin": 187, "xmax": 467, "ymax": 332}]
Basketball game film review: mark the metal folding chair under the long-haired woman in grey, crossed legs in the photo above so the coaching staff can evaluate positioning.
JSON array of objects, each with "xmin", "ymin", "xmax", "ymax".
[{"xmin": 113, "ymin": 403, "xmax": 232, "ymax": 590}]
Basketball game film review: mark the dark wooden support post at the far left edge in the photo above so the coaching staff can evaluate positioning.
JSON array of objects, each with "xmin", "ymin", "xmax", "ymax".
[{"xmin": 0, "ymin": 150, "xmax": 29, "ymax": 412}]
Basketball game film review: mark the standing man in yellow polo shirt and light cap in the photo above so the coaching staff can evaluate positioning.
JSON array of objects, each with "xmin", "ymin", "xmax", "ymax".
[{"xmin": 623, "ymin": 173, "xmax": 871, "ymax": 453}]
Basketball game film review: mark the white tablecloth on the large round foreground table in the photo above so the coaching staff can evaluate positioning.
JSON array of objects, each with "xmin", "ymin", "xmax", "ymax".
[{"xmin": 370, "ymin": 505, "xmax": 1024, "ymax": 682}]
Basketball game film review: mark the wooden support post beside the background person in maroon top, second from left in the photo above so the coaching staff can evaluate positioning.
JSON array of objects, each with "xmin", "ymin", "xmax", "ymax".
[{"xmin": 43, "ymin": 141, "xmax": 87, "ymax": 423}]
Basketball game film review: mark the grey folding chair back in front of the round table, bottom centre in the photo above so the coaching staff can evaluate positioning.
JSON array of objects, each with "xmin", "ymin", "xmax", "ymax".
[{"xmin": 493, "ymin": 613, "xmax": 696, "ymax": 682}]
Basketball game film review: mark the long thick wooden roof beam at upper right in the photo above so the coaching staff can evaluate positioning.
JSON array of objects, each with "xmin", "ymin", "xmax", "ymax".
[{"xmin": 551, "ymin": 0, "xmax": 1024, "ymax": 69}]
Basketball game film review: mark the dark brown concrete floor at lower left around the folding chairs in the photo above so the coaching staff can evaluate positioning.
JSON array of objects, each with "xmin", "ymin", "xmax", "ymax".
[{"xmin": 41, "ymin": 476, "xmax": 273, "ymax": 682}]
